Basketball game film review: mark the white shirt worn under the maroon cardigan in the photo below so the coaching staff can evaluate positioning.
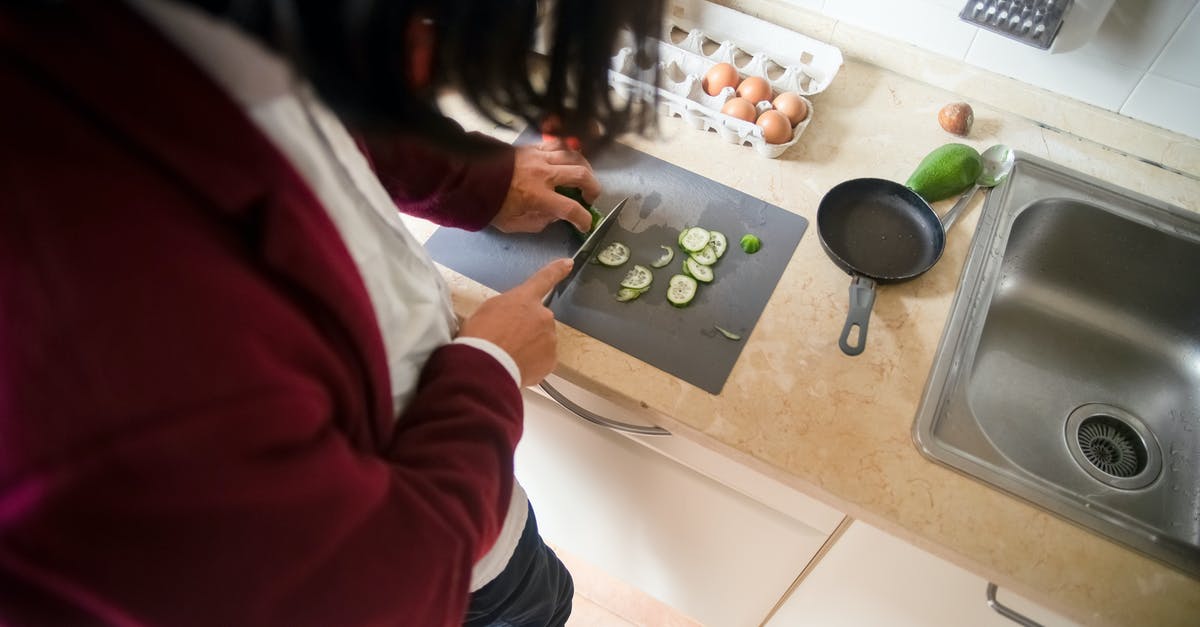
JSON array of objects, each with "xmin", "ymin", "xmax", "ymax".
[{"xmin": 128, "ymin": 0, "xmax": 528, "ymax": 591}]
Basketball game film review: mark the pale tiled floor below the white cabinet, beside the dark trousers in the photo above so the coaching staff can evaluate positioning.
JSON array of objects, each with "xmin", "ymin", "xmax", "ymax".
[{"xmin": 554, "ymin": 538, "xmax": 702, "ymax": 627}]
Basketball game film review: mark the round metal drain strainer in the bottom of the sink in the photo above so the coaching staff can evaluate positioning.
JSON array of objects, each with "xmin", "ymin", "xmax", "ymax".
[{"xmin": 1067, "ymin": 402, "xmax": 1163, "ymax": 490}]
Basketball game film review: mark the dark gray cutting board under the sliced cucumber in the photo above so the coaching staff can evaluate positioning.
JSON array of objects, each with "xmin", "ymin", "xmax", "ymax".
[{"xmin": 426, "ymin": 132, "xmax": 808, "ymax": 394}]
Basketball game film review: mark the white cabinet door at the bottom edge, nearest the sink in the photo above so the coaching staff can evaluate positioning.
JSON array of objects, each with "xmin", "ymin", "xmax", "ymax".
[{"xmin": 767, "ymin": 521, "xmax": 1076, "ymax": 627}]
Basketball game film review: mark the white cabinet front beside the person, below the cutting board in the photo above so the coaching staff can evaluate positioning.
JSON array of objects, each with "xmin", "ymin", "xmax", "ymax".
[{"xmin": 516, "ymin": 392, "xmax": 828, "ymax": 627}]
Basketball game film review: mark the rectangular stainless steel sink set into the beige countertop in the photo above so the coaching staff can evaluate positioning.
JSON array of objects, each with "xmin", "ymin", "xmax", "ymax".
[{"xmin": 913, "ymin": 153, "xmax": 1200, "ymax": 577}]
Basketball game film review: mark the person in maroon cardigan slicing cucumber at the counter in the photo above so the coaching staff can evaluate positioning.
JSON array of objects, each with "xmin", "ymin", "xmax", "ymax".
[{"xmin": 0, "ymin": 0, "xmax": 661, "ymax": 626}]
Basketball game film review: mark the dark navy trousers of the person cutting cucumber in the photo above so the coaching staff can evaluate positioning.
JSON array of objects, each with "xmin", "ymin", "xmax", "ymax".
[{"xmin": 463, "ymin": 506, "xmax": 575, "ymax": 627}]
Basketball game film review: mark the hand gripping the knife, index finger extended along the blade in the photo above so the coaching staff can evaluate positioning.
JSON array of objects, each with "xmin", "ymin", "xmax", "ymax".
[{"xmin": 458, "ymin": 258, "xmax": 572, "ymax": 387}]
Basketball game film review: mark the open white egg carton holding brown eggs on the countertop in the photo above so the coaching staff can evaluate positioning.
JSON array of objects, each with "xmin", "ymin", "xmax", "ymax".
[{"xmin": 608, "ymin": 0, "xmax": 842, "ymax": 159}]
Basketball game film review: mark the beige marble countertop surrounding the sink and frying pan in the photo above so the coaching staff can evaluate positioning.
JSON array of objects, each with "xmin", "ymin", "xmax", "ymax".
[{"xmin": 422, "ymin": 54, "xmax": 1200, "ymax": 626}]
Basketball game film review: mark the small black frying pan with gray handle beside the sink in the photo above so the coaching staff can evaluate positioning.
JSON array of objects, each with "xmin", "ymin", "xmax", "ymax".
[{"xmin": 817, "ymin": 179, "xmax": 953, "ymax": 356}]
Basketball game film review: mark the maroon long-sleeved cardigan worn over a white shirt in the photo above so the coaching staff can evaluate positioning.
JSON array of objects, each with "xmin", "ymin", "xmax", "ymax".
[{"xmin": 0, "ymin": 0, "xmax": 522, "ymax": 626}]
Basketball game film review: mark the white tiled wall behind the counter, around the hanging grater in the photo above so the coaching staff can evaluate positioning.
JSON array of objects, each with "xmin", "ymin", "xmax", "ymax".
[{"xmin": 768, "ymin": 0, "xmax": 1200, "ymax": 138}]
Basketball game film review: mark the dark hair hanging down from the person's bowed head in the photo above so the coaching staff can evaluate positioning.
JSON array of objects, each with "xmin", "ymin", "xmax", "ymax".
[{"xmin": 188, "ymin": 0, "xmax": 662, "ymax": 145}]
